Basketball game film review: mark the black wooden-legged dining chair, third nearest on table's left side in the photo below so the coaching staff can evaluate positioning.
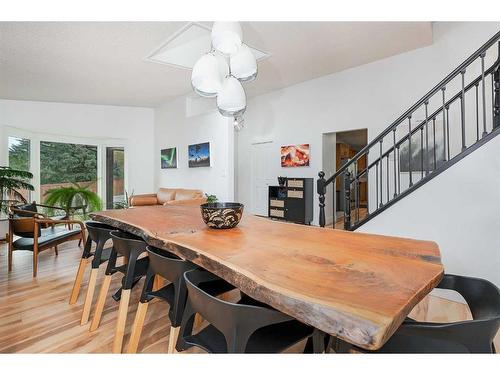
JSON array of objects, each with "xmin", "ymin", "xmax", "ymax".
[{"xmin": 90, "ymin": 230, "xmax": 149, "ymax": 353}]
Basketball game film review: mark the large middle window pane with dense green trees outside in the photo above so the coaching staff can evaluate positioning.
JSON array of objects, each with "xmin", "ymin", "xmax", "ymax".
[{"xmin": 40, "ymin": 141, "xmax": 97, "ymax": 200}]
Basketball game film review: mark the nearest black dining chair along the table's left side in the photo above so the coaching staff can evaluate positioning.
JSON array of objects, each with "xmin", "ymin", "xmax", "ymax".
[{"xmin": 176, "ymin": 270, "xmax": 314, "ymax": 353}]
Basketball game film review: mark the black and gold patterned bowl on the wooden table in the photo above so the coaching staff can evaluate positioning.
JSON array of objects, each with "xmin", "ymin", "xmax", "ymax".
[{"xmin": 200, "ymin": 202, "xmax": 244, "ymax": 229}]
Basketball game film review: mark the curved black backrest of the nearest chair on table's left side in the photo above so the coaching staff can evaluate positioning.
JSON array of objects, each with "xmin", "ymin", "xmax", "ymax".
[{"xmin": 184, "ymin": 270, "xmax": 292, "ymax": 341}]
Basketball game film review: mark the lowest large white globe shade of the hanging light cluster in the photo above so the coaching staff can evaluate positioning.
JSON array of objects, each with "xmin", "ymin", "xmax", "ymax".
[{"xmin": 217, "ymin": 76, "xmax": 247, "ymax": 117}]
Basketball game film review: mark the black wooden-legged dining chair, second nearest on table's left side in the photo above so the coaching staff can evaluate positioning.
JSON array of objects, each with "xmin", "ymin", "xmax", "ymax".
[{"xmin": 127, "ymin": 246, "xmax": 235, "ymax": 353}]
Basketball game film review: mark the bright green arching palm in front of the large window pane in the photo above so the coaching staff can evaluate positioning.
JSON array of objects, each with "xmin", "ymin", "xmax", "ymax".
[{"xmin": 45, "ymin": 182, "xmax": 102, "ymax": 218}]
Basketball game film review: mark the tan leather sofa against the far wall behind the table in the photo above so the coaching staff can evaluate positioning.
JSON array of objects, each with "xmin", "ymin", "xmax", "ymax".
[{"xmin": 129, "ymin": 188, "xmax": 207, "ymax": 207}]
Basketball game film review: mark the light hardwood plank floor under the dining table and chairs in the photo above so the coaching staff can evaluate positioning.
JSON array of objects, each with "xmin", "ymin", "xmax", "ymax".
[{"xmin": 0, "ymin": 241, "xmax": 500, "ymax": 353}]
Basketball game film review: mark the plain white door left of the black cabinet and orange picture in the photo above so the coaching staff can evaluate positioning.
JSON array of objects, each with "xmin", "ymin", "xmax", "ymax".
[{"xmin": 251, "ymin": 142, "xmax": 279, "ymax": 216}]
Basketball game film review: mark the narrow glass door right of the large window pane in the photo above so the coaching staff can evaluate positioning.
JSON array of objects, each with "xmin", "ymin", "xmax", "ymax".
[{"xmin": 106, "ymin": 147, "xmax": 127, "ymax": 209}]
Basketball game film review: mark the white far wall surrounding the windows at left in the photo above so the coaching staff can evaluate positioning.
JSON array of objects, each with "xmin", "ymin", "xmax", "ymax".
[{"xmin": 0, "ymin": 100, "xmax": 154, "ymax": 198}]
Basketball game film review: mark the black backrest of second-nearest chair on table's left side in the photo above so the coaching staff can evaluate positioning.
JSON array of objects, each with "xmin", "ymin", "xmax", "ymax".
[{"xmin": 146, "ymin": 246, "xmax": 197, "ymax": 283}]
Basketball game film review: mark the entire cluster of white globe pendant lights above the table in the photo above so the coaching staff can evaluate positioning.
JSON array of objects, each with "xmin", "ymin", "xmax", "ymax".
[{"xmin": 191, "ymin": 22, "xmax": 257, "ymax": 130}]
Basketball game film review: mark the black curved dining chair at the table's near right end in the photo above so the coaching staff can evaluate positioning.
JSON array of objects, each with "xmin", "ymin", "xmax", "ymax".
[{"xmin": 332, "ymin": 275, "xmax": 500, "ymax": 353}]
